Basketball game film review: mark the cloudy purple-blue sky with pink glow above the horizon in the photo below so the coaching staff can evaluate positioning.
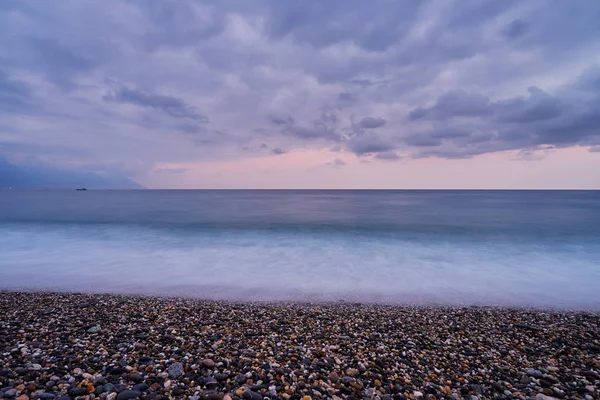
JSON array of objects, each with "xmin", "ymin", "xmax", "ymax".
[{"xmin": 0, "ymin": 0, "xmax": 600, "ymax": 189}]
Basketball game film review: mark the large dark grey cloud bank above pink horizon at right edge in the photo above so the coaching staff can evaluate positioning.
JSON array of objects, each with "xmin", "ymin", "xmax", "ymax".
[{"xmin": 404, "ymin": 68, "xmax": 600, "ymax": 160}]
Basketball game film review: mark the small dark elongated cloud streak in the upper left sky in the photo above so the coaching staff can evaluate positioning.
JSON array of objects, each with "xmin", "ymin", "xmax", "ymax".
[{"xmin": 104, "ymin": 87, "xmax": 208, "ymax": 122}]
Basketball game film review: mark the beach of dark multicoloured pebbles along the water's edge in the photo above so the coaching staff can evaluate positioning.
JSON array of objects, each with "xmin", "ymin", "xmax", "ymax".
[{"xmin": 0, "ymin": 292, "xmax": 600, "ymax": 400}]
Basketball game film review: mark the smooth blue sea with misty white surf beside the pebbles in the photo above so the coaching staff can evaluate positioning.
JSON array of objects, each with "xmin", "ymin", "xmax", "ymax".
[{"xmin": 0, "ymin": 190, "xmax": 600, "ymax": 309}]
